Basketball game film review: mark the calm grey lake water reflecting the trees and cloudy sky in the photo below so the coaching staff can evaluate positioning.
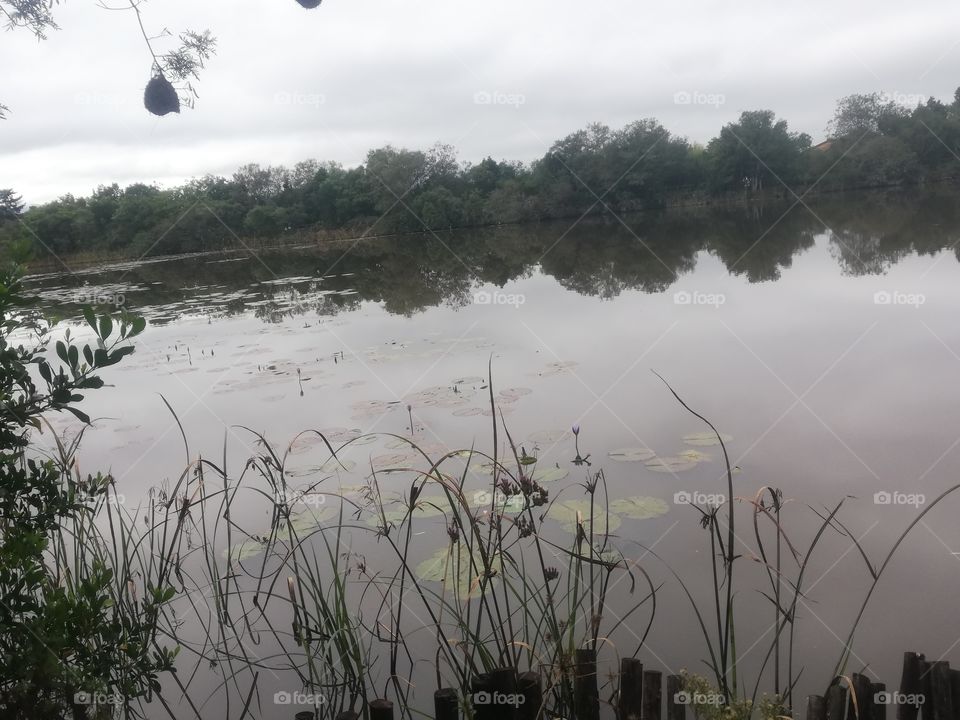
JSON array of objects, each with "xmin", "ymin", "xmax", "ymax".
[{"xmin": 20, "ymin": 191, "xmax": 960, "ymax": 720}]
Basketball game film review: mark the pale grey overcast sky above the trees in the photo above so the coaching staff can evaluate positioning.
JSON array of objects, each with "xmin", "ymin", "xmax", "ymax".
[{"xmin": 0, "ymin": 0, "xmax": 960, "ymax": 203}]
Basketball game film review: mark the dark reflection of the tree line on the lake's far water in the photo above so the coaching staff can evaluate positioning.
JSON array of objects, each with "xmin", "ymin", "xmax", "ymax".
[{"xmin": 20, "ymin": 188, "xmax": 960, "ymax": 324}]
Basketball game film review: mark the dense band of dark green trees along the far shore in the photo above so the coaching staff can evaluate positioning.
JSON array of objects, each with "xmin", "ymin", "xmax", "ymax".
[{"xmin": 0, "ymin": 89, "xmax": 960, "ymax": 262}]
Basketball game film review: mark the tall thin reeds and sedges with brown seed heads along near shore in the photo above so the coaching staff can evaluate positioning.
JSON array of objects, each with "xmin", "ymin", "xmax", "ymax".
[{"xmin": 31, "ymin": 377, "xmax": 960, "ymax": 720}]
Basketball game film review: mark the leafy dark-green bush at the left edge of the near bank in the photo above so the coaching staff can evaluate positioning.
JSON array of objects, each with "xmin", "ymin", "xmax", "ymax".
[{"xmin": 0, "ymin": 272, "xmax": 176, "ymax": 718}]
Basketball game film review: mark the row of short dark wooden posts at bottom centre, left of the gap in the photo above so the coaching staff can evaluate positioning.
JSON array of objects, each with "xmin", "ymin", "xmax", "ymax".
[{"xmin": 295, "ymin": 649, "xmax": 684, "ymax": 720}]
